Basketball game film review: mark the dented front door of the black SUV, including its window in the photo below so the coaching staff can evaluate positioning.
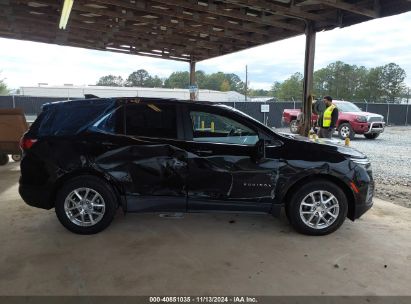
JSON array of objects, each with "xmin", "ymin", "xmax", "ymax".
[{"xmin": 184, "ymin": 105, "xmax": 279, "ymax": 211}]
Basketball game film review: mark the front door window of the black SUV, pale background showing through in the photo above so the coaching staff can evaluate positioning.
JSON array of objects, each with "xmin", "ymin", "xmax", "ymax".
[{"xmin": 190, "ymin": 111, "xmax": 258, "ymax": 145}]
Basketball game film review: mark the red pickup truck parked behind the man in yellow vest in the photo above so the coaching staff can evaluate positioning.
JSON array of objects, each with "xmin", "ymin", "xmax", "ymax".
[{"xmin": 282, "ymin": 100, "xmax": 385, "ymax": 139}]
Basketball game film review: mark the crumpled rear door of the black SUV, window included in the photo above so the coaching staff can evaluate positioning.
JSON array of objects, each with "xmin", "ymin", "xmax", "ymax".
[{"xmin": 94, "ymin": 101, "xmax": 188, "ymax": 211}]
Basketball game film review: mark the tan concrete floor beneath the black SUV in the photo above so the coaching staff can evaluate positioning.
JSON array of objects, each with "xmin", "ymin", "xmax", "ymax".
[{"xmin": 0, "ymin": 163, "xmax": 411, "ymax": 296}]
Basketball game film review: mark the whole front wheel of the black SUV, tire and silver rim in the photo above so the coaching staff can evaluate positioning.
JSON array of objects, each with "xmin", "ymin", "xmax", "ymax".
[{"xmin": 286, "ymin": 180, "xmax": 348, "ymax": 235}]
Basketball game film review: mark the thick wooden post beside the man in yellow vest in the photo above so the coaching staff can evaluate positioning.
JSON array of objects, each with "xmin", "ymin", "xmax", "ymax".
[{"xmin": 300, "ymin": 21, "xmax": 316, "ymax": 136}]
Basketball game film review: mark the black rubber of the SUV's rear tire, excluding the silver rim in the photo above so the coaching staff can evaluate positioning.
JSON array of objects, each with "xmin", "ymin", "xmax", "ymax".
[{"xmin": 55, "ymin": 175, "xmax": 118, "ymax": 234}]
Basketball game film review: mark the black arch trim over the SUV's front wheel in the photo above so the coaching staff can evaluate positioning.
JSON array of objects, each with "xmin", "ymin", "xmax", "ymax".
[{"xmin": 282, "ymin": 174, "xmax": 355, "ymax": 220}]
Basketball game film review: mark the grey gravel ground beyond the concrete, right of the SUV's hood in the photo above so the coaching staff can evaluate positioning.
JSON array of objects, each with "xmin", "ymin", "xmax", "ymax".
[{"xmin": 276, "ymin": 127, "xmax": 411, "ymax": 208}]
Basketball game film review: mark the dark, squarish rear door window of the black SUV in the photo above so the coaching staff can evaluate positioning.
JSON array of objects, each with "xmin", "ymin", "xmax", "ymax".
[{"xmin": 125, "ymin": 103, "xmax": 177, "ymax": 138}]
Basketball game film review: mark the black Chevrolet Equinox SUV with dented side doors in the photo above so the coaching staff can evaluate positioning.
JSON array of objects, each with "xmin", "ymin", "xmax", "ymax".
[{"xmin": 19, "ymin": 98, "xmax": 374, "ymax": 235}]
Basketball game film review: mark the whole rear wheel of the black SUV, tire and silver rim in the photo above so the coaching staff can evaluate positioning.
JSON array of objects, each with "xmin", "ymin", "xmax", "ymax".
[{"xmin": 55, "ymin": 175, "xmax": 117, "ymax": 234}]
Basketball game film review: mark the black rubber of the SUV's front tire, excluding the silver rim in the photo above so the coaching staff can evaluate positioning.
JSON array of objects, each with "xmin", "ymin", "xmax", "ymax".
[{"xmin": 286, "ymin": 179, "xmax": 348, "ymax": 235}]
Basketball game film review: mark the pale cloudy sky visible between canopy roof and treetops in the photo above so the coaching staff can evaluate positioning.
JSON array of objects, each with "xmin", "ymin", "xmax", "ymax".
[{"xmin": 0, "ymin": 12, "xmax": 411, "ymax": 89}]
